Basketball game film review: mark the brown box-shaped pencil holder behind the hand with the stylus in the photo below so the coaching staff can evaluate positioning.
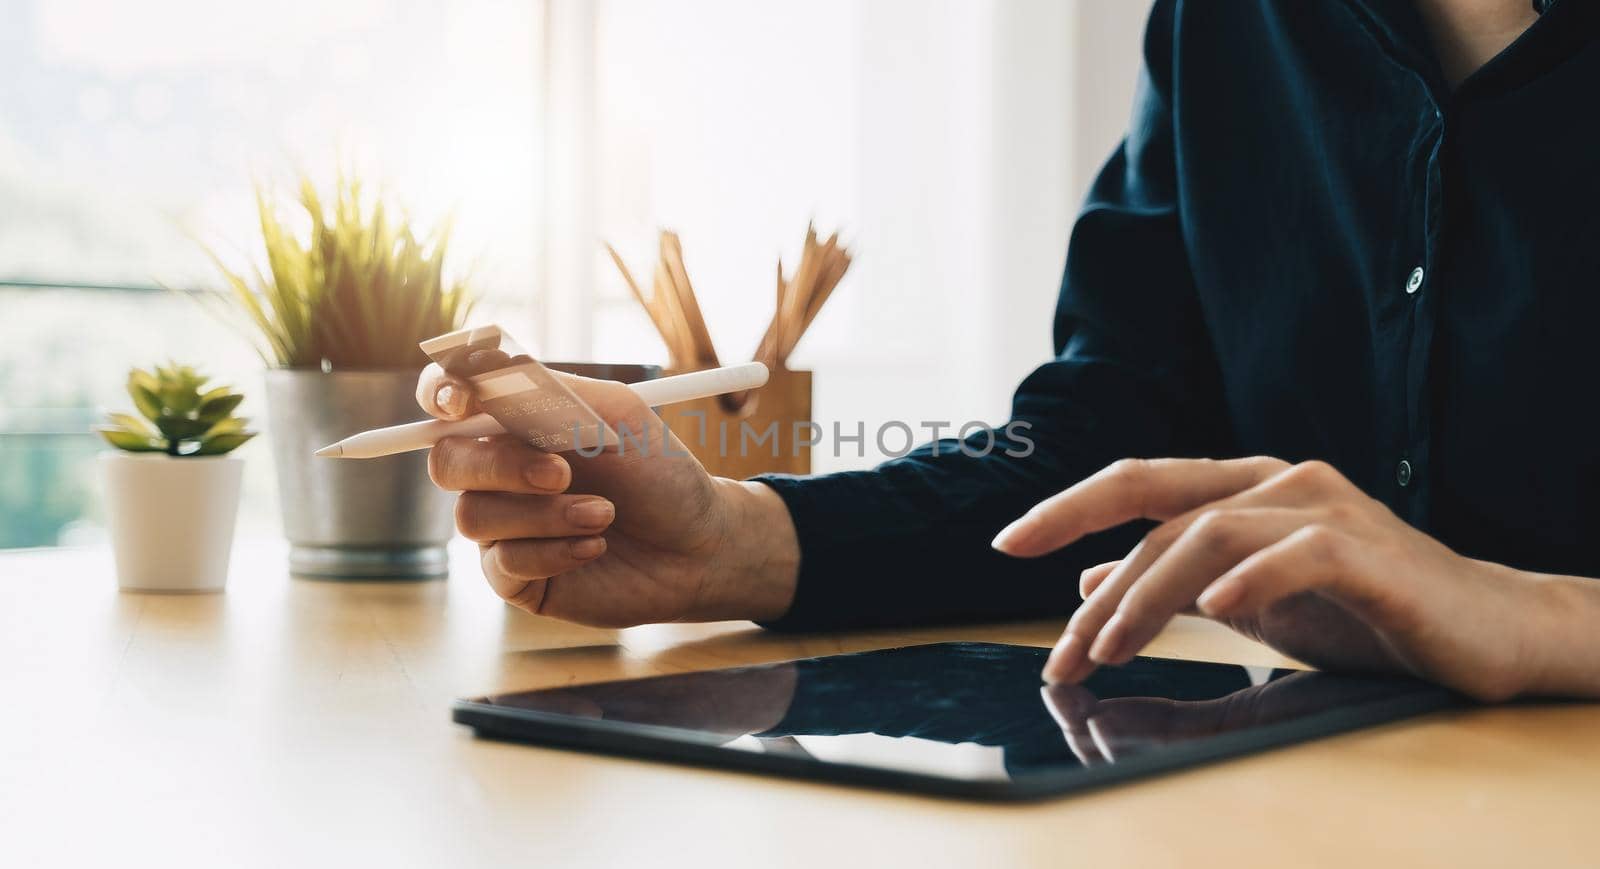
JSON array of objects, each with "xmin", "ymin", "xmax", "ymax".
[{"xmin": 659, "ymin": 368, "xmax": 822, "ymax": 480}]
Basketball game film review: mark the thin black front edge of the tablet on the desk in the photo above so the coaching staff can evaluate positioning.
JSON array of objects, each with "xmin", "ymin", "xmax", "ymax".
[{"xmin": 451, "ymin": 643, "xmax": 1464, "ymax": 802}]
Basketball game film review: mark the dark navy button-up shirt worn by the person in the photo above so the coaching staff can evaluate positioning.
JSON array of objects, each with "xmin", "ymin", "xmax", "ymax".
[{"xmin": 763, "ymin": 0, "xmax": 1600, "ymax": 629}]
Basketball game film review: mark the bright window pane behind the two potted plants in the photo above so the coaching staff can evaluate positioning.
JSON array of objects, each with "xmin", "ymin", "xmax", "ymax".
[{"xmin": 0, "ymin": 0, "xmax": 544, "ymax": 547}]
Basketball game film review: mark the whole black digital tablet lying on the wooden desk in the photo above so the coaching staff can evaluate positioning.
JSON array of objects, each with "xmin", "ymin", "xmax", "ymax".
[{"xmin": 454, "ymin": 643, "xmax": 1461, "ymax": 799}]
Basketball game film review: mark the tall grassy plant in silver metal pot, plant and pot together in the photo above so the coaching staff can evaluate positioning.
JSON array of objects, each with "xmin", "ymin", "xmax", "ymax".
[{"xmin": 213, "ymin": 176, "xmax": 472, "ymax": 578}]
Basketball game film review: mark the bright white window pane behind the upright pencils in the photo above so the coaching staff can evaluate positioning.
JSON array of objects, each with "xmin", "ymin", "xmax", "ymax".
[{"xmin": 594, "ymin": 0, "xmax": 861, "ymax": 371}]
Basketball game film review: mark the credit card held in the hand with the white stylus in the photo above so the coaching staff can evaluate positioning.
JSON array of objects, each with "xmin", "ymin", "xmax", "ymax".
[{"xmin": 421, "ymin": 325, "xmax": 618, "ymax": 453}]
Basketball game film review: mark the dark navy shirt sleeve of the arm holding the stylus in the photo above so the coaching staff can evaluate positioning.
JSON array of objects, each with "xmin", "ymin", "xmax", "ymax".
[{"xmin": 757, "ymin": 0, "xmax": 1224, "ymax": 631}]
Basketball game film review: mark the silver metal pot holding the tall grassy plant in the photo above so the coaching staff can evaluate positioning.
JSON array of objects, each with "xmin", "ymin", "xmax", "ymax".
[{"xmin": 267, "ymin": 368, "xmax": 456, "ymax": 579}]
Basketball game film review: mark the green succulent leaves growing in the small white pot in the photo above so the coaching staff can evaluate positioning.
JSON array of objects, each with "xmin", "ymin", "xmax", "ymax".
[{"xmin": 94, "ymin": 363, "xmax": 256, "ymax": 456}]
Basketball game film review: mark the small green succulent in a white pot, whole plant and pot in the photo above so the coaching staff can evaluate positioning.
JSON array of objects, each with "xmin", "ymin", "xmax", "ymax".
[{"xmin": 96, "ymin": 363, "xmax": 256, "ymax": 592}]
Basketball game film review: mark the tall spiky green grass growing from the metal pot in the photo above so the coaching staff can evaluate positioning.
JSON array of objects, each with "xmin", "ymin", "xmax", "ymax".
[{"xmin": 208, "ymin": 173, "xmax": 472, "ymax": 371}]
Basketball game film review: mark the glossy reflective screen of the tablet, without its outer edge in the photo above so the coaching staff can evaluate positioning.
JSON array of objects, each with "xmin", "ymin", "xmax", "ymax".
[{"xmin": 478, "ymin": 643, "xmax": 1446, "ymax": 781}]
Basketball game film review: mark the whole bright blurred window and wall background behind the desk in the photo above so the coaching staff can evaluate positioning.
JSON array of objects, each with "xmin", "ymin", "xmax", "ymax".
[{"xmin": 0, "ymin": 0, "xmax": 1146, "ymax": 547}]
